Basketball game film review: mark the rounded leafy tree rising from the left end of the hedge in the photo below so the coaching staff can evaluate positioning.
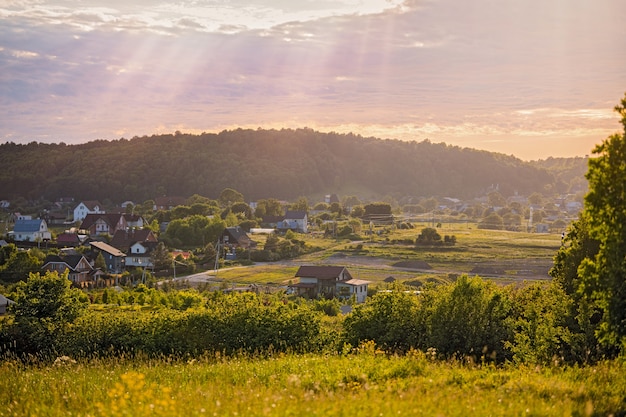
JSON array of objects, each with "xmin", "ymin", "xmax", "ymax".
[{"xmin": 14, "ymin": 271, "xmax": 87, "ymax": 323}]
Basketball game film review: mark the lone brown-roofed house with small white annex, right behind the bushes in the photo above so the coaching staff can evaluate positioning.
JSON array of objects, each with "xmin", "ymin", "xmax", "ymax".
[{"xmin": 290, "ymin": 265, "xmax": 369, "ymax": 302}]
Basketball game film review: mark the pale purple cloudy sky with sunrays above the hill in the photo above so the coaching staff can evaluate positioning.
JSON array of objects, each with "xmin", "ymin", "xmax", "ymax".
[{"xmin": 0, "ymin": 0, "xmax": 626, "ymax": 160}]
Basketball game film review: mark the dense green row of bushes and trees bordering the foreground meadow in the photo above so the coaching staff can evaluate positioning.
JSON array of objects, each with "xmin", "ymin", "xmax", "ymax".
[{"xmin": 0, "ymin": 273, "xmax": 614, "ymax": 364}]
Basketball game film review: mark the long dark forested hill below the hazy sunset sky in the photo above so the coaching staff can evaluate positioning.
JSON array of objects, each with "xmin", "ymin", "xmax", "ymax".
[{"xmin": 0, "ymin": 129, "xmax": 584, "ymax": 202}]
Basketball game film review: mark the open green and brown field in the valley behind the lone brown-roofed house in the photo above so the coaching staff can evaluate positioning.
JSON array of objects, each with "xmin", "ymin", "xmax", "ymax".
[{"xmin": 186, "ymin": 223, "xmax": 561, "ymax": 285}]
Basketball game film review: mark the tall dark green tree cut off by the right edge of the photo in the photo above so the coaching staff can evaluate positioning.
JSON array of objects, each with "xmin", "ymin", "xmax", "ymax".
[{"xmin": 551, "ymin": 92, "xmax": 626, "ymax": 356}]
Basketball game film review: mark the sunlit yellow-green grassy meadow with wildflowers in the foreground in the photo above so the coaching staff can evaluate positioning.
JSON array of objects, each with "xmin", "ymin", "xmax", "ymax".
[{"xmin": 0, "ymin": 351, "xmax": 626, "ymax": 416}]
